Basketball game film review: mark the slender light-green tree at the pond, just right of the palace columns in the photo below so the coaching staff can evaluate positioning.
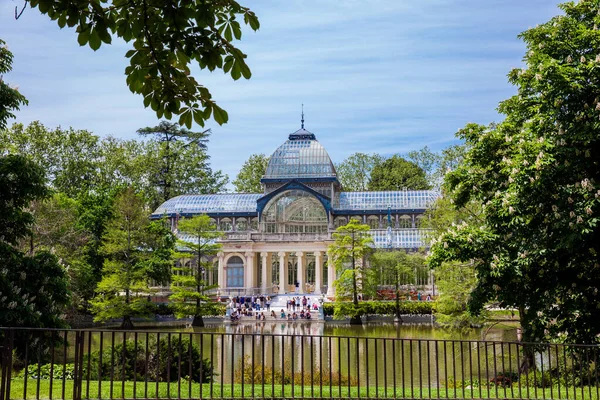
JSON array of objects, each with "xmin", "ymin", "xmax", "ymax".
[{"xmin": 328, "ymin": 218, "xmax": 373, "ymax": 324}]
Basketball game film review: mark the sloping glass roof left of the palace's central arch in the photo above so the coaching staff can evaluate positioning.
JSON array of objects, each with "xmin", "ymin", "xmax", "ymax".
[{"xmin": 152, "ymin": 193, "xmax": 263, "ymax": 217}]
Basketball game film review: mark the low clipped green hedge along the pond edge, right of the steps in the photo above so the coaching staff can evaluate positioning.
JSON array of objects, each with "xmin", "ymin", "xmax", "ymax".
[{"xmin": 323, "ymin": 301, "xmax": 435, "ymax": 317}]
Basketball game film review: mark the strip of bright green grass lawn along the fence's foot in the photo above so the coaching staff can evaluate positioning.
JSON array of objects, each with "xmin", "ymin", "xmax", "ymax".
[{"xmin": 10, "ymin": 380, "xmax": 599, "ymax": 400}]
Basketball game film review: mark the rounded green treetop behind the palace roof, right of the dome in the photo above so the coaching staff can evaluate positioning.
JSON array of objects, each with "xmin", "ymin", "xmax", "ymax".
[{"xmin": 369, "ymin": 155, "xmax": 430, "ymax": 190}]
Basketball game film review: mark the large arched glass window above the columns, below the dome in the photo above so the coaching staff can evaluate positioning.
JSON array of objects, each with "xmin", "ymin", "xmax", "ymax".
[{"xmin": 262, "ymin": 190, "xmax": 327, "ymax": 233}]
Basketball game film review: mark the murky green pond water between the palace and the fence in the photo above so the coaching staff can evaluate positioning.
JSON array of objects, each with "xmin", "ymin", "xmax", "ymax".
[{"xmin": 81, "ymin": 321, "xmax": 518, "ymax": 387}]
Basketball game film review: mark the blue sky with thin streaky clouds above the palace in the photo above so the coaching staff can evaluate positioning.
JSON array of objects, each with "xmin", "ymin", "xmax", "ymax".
[{"xmin": 0, "ymin": 0, "xmax": 559, "ymax": 184}]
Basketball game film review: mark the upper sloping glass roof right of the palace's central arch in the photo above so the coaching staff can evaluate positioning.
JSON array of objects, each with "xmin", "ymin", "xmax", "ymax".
[{"xmin": 334, "ymin": 190, "xmax": 440, "ymax": 210}]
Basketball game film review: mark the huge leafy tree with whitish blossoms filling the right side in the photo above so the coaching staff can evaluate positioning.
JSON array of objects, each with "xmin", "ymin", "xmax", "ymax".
[{"xmin": 432, "ymin": 1, "xmax": 600, "ymax": 344}]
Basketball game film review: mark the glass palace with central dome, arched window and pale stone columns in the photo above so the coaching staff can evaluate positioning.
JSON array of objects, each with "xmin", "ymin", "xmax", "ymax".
[{"xmin": 152, "ymin": 128, "xmax": 438, "ymax": 296}]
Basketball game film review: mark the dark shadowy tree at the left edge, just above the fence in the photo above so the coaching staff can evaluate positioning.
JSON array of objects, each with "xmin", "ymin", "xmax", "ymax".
[{"xmin": 0, "ymin": 155, "xmax": 69, "ymax": 328}]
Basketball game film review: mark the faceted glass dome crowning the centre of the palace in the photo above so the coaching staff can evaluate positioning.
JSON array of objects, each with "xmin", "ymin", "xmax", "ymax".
[{"xmin": 264, "ymin": 129, "xmax": 336, "ymax": 179}]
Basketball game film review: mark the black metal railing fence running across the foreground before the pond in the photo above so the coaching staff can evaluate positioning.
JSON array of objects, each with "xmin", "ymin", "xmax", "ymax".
[{"xmin": 0, "ymin": 328, "xmax": 600, "ymax": 400}]
